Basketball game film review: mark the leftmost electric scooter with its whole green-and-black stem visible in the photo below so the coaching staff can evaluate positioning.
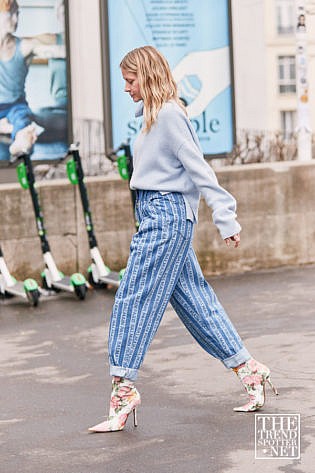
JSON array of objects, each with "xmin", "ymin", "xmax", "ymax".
[{"xmin": 16, "ymin": 153, "xmax": 87, "ymax": 300}]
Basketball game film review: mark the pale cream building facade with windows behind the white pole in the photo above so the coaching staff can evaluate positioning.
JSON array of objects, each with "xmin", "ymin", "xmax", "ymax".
[{"xmin": 233, "ymin": 0, "xmax": 315, "ymax": 135}]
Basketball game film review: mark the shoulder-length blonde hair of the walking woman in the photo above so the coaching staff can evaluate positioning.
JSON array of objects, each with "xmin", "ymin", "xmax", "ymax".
[{"xmin": 120, "ymin": 46, "xmax": 186, "ymax": 131}]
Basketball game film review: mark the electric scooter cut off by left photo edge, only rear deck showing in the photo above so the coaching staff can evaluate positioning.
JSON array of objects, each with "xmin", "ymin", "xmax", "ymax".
[{"xmin": 0, "ymin": 246, "xmax": 40, "ymax": 307}]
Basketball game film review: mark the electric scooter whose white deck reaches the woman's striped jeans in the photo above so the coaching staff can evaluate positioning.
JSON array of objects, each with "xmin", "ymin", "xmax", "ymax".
[{"xmin": 66, "ymin": 143, "xmax": 122, "ymax": 289}]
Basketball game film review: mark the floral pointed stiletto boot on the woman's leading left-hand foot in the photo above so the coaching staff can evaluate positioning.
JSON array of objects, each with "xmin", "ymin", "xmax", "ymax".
[{"xmin": 89, "ymin": 377, "xmax": 141, "ymax": 433}]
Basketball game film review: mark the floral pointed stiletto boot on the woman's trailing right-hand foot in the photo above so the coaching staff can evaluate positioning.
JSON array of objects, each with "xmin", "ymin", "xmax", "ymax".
[{"xmin": 233, "ymin": 358, "xmax": 278, "ymax": 412}]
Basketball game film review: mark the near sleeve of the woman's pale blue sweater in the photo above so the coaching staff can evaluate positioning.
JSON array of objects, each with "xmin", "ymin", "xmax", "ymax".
[{"xmin": 163, "ymin": 107, "xmax": 241, "ymax": 239}]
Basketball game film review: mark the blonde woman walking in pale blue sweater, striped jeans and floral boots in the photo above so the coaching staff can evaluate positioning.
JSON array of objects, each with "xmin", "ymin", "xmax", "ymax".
[{"xmin": 89, "ymin": 46, "xmax": 276, "ymax": 432}]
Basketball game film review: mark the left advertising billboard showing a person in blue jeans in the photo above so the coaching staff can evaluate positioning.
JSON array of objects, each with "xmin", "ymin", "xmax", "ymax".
[{"xmin": 0, "ymin": 0, "xmax": 70, "ymax": 164}]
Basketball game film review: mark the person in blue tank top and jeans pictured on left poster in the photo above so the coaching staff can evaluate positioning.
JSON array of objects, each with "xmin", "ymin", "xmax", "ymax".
[{"xmin": 0, "ymin": 0, "xmax": 65, "ymax": 159}]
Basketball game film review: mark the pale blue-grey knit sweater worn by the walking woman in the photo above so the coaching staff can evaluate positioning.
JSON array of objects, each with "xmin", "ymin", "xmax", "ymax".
[{"xmin": 130, "ymin": 101, "xmax": 241, "ymax": 238}]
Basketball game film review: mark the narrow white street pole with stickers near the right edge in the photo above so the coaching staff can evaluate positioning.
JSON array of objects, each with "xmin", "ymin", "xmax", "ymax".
[{"xmin": 295, "ymin": 0, "xmax": 312, "ymax": 161}]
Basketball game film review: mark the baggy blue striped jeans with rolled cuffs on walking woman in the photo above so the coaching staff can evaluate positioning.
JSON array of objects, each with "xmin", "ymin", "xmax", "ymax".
[{"xmin": 109, "ymin": 191, "xmax": 251, "ymax": 380}]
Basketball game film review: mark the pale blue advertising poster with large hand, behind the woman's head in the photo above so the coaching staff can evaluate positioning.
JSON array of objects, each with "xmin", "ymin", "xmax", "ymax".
[{"xmin": 101, "ymin": 0, "xmax": 235, "ymax": 156}]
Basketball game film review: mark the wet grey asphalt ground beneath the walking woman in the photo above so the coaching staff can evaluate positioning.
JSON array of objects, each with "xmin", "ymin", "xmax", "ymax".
[{"xmin": 0, "ymin": 266, "xmax": 315, "ymax": 473}]
